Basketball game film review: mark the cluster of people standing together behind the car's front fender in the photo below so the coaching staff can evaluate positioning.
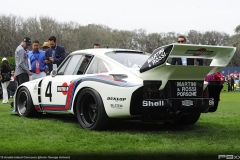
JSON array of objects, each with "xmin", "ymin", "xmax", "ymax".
[{"xmin": 15, "ymin": 36, "xmax": 66, "ymax": 85}]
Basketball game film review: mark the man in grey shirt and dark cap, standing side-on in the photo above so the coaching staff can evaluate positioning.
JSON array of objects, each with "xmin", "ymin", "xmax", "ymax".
[{"xmin": 15, "ymin": 37, "xmax": 32, "ymax": 85}]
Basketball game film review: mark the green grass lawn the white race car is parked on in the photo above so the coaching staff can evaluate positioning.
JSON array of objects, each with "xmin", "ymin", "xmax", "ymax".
[{"xmin": 0, "ymin": 91, "xmax": 240, "ymax": 160}]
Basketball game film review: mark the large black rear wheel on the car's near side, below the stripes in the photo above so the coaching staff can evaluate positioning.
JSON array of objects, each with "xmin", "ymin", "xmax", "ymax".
[{"xmin": 76, "ymin": 88, "xmax": 109, "ymax": 130}]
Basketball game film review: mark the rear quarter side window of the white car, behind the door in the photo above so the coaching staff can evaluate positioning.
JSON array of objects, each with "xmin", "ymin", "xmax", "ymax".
[{"xmin": 86, "ymin": 57, "xmax": 111, "ymax": 74}]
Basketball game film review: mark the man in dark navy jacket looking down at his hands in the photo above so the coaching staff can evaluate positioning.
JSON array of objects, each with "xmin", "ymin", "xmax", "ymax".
[{"xmin": 45, "ymin": 36, "xmax": 66, "ymax": 73}]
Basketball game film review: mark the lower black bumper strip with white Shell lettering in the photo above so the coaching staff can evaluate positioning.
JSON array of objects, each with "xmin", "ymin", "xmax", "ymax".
[{"xmin": 141, "ymin": 98, "xmax": 214, "ymax": 114}]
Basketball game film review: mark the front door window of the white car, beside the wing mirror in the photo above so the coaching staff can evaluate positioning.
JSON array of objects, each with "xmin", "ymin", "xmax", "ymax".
[{"xmin": 58, "ymin": 55, "xmax": 83, "ymax": 75}]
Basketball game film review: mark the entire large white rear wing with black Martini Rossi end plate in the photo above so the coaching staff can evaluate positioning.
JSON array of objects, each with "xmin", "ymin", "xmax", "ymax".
[{"xmin": 135, "ymin": 44, "xmax": 236, "ymax": 88}]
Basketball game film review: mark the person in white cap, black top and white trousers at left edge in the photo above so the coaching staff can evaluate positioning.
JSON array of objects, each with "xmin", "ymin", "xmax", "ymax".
[{"xmin": 1, "ymin": 57, "xmax": 11, "ymax": 104}]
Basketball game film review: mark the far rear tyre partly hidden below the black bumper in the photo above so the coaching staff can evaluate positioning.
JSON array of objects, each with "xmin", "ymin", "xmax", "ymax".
[{"xmin": 165, "ymin": 113, "xmax": 201, "ymax": 125}]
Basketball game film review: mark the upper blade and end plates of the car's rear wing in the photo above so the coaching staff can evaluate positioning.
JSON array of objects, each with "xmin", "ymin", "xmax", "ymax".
[{"xmin": 140, "ymin": 43, "xmax": 236, "ymax": 72}]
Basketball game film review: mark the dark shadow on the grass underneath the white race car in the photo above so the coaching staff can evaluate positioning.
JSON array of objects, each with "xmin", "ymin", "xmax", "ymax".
[{"xmin": 9, "ymin": 113, "xmax": 229, "ymax": 133}]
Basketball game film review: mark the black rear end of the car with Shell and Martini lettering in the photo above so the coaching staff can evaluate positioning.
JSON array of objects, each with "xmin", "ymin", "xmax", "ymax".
[{"xmin": 130, "ymin": 80, "xmax": 219, "ymax": 115}]
